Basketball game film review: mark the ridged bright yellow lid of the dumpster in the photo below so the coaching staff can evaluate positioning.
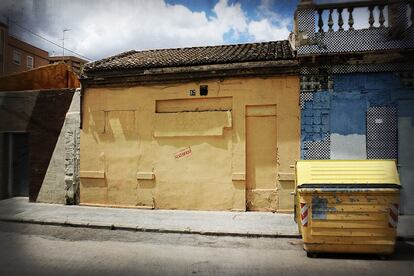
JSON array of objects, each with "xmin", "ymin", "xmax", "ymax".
[{"xmin": 296, "ymin": 160, "xmax": 400, "ymax": 188}]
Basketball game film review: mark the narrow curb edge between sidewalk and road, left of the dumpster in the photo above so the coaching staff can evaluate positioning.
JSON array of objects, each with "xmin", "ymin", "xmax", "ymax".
[{"xmin": 0, "ymin": 218, "xmax": 301, "ymax": 238}]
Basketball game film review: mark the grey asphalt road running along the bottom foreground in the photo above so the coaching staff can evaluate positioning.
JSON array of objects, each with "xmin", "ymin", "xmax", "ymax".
[{"xmin": 0, "ymin": 222, "xmax": 414, "ymax": 276}]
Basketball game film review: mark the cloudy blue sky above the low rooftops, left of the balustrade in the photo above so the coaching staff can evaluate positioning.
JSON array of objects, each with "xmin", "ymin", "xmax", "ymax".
[{"xmin": 0, "ymin": 0, "xmax": 299, "ymax": 60}]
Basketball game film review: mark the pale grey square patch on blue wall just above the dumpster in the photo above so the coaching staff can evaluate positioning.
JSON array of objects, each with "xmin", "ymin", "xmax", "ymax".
[{"xmin": 330, "ymin": 133, "xmax": 367, "ymax": 160}]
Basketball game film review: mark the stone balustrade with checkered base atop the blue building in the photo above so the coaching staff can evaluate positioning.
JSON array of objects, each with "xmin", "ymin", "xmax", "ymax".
[{"xmin": 295, "ymin": 0, "xmax": 414, "ymax": 55}]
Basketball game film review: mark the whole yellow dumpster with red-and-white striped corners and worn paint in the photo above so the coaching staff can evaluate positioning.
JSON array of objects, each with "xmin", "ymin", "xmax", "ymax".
[{"xmin": 295, "ymin": 160, "xmax": 401, "ymax": 256}]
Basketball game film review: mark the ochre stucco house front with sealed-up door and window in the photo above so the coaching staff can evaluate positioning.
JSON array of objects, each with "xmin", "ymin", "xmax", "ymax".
[{"xmin": 80, "ymin": 76, "xmax": 300, "ymax": 211}]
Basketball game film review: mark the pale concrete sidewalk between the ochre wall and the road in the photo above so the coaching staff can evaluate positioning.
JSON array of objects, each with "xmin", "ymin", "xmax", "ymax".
[{"xmin": 0, "ymin": 197, "xmax": 414, "ymax": 239}]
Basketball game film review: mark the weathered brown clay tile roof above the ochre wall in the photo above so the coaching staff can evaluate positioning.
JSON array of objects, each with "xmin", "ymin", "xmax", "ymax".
[{"xmin": 84, "ymin": 40, "xmax": 294, "ymax": 75}]
